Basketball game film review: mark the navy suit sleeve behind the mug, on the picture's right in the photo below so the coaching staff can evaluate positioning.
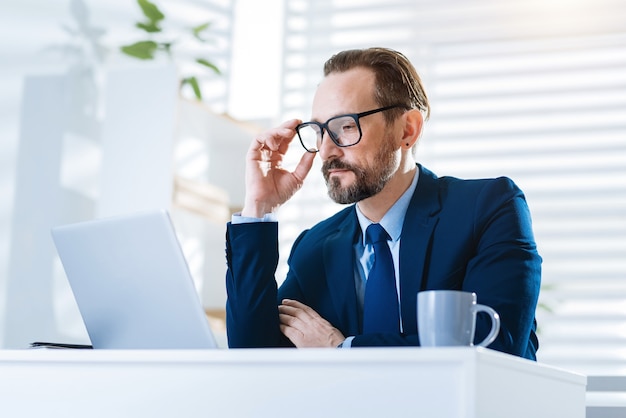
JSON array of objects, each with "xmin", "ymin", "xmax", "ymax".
[{"xmin": 463, "ymin": 178, "xmax": 542, "ymax": 359}]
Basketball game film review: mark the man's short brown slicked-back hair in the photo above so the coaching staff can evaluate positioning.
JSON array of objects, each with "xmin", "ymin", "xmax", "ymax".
[{"xmin": 324, "ymin": 48, "xmax": 430, "ymax": 121}]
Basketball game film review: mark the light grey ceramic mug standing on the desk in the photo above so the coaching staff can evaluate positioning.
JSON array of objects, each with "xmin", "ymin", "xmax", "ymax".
[{"xmin": 417, "ymin": 290, "xmax": 500, "ymax": 347}]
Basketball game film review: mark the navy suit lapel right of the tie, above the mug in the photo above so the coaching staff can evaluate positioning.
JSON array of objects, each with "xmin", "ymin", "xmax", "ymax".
[{"xmin": 399, "ymin": 165, "xmax": 441, "ymax": 332}]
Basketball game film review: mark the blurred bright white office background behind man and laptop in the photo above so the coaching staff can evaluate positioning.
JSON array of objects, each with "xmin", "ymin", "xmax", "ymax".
[{"xmin": 0, "ymin": 0, "xmax": 626, "ymax": 374}]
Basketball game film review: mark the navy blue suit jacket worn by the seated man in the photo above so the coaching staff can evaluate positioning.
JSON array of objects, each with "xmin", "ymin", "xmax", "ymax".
[{"xmin": 226, "ymin": 166, "xmax": 541, "ymax": 359}]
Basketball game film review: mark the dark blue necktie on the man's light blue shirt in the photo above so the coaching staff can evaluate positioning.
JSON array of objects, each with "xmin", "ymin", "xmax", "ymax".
[{"xmin": 363, "ymin": 224, "xmax": 400, "ymax": 334}]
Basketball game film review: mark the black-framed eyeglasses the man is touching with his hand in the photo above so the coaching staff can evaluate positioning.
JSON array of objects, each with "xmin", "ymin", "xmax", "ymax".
[{"xmin": 296, "ymin": 104, "xmax": 405, "ymax": 153}]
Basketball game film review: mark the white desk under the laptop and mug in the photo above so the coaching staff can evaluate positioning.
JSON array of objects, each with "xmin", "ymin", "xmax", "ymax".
[{"xmin": 0, "ymin": 348, "xmax": 586, "ymax": 418}]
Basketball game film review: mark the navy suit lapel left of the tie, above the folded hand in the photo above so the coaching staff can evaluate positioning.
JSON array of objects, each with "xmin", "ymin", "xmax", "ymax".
[{"xmin": 324, "ymin": 211, "xmax": 360, "ymax": 335}]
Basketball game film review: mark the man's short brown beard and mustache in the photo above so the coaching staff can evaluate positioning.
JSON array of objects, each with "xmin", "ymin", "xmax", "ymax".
[{"xmin": 322, "ymin": 138, "xmax": 398, "ymax": 204}]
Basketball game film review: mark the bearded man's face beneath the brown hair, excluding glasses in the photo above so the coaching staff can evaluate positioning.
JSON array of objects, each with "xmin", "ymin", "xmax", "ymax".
[{"xmin": 313, "ymin": 68, "xmax": 399, "ymax": 204}]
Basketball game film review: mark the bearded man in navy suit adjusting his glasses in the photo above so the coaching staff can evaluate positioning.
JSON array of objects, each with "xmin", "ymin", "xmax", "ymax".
[{"xmin": 226, "ymin": 48, "xmax": 541, "ymax": 359}]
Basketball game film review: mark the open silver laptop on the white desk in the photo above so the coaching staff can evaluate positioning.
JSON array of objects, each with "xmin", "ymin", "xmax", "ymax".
[{"xmin": 51, "ymin": 210, "xmax": 217, "ymax": 349}]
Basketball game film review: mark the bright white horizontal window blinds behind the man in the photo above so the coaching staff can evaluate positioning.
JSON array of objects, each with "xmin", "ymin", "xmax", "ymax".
[{"xmin": 278, "ymin": 0, "xmax": 626, "ymax": 374}]
